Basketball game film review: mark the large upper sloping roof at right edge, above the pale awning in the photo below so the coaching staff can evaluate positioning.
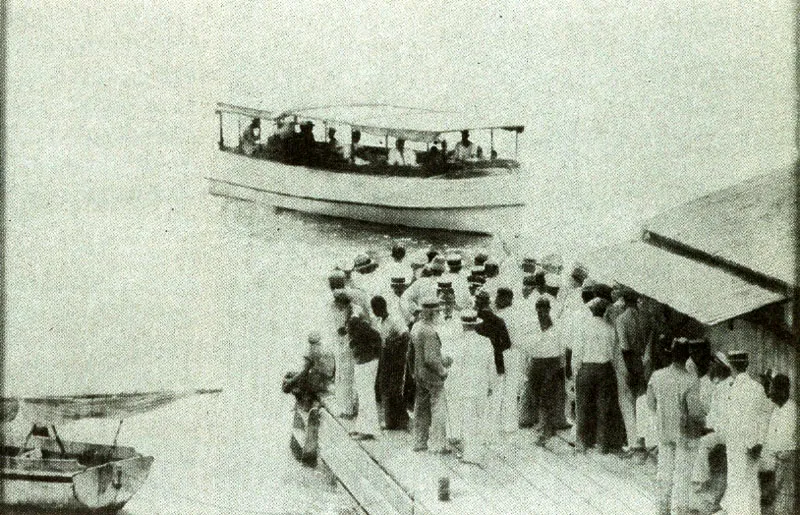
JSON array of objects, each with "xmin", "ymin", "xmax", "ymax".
[{"xmin": 644, "ymin": 168, "xmax": 797, "ymax": 285}]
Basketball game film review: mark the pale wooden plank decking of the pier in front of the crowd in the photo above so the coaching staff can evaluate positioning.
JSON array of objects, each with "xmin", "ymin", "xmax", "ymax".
[{"xmin": 319, "ymin": 410, "xmax": 656, "ymax": 515}]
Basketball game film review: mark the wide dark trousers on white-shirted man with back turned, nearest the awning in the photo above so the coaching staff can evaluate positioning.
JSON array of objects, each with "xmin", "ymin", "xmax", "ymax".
[{"xmin": 575, "ymin": 363, "xmax": 619, "ymax": 451}]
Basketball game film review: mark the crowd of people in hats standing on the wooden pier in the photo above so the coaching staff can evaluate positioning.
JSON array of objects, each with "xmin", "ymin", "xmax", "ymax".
[{"xmin": 284, "ymin": 244, "xmax": 797, "ymax": 514}]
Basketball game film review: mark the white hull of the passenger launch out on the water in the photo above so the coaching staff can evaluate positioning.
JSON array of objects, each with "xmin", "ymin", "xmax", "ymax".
[{"xmin": 208, "ymin": 152, "xmax": 524, "ymax": 234}]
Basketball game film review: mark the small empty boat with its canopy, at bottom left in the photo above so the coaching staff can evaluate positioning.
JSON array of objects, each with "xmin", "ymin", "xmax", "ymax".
[{"xmin": 0, "ymin": 390, "xmax": 218, "ymax": 513}]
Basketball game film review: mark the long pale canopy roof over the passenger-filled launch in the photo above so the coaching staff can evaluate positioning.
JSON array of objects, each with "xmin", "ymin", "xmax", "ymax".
[{"xmin": 217, "ymin": 103, "xmax": 525, "ymax": 143}]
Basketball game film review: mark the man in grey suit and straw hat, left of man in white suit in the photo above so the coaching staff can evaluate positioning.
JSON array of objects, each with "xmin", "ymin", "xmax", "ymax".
[{"xmin": 411, "ymin": 297, "xmax": 451, "ymax": 453}]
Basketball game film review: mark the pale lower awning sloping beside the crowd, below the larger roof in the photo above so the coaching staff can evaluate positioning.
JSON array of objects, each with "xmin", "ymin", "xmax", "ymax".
[{"xmin": 579, "ymin": 241, "xmax": 786, "ymax": 325}]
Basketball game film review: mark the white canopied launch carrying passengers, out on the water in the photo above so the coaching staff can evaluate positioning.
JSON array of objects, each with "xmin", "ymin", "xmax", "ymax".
[{"xmin": 207, "ymin": 103, "xmax": 525, "ymax": 234}]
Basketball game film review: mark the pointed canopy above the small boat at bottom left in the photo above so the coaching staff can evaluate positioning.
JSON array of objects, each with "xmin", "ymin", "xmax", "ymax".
[{"xmin": 3, "ymin": 390, "xmax": 220, "ymax": 425}]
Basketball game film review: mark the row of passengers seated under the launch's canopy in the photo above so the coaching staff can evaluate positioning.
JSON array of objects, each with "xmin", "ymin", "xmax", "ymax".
[{"xmin": 239, "ymin": 118, "xmax": 497, "ymax": 171}]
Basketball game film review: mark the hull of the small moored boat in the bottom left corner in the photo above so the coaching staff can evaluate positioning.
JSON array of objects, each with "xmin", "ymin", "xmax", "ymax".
[{"xmin": 0, "ymin": 438, "xmax": 153, "ymax": 513}]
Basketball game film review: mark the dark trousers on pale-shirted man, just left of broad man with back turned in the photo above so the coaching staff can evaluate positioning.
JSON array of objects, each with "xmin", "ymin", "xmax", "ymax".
[{"xmin": 520, "ymin": 358, "xmax": 564, "ymax": 437}]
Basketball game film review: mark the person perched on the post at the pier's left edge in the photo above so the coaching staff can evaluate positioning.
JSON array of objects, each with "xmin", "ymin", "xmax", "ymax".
[{"xmin": 281, "ymin": 332, "xmax": 334, "ymax": 408}]
